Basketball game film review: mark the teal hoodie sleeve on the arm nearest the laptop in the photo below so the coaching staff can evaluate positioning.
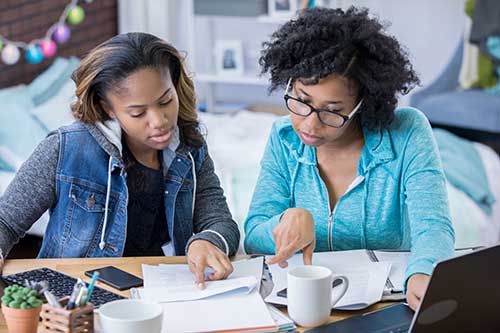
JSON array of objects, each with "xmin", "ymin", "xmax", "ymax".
[{"xmin": 402, "ymin": 111, "xmax": 455, "ymax": 291}]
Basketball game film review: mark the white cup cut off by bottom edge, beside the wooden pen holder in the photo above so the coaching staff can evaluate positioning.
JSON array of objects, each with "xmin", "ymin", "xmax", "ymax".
[{"xmin": 99, "ymin": 299, "xmax": 163, "ymax": 333}]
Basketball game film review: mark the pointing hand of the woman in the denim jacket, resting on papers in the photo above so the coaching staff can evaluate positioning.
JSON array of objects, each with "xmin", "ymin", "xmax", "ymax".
[{"xmin": 187, "ymin": 239, "xmax": 233, "ymax": 289}]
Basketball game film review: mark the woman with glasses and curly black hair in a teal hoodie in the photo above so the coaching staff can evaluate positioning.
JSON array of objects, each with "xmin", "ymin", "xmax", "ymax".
[{"xmin": 245, "ymin": 7, "xmax": 454, "ymax": 309}]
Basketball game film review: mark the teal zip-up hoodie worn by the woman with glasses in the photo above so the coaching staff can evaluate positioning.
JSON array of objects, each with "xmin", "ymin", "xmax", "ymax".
[{"xmin": 245, "ymin": 108, "xmax": 455, "ymax": 279}]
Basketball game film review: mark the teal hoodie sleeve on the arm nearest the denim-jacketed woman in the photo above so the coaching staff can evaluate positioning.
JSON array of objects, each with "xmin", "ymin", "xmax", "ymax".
[{"xmin": 245, "ymin": 124, "xmax": 291, "ymax": 254}]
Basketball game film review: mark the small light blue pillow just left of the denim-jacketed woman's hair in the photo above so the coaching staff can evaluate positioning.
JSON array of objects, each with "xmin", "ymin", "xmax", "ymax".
[{"xmin": 26, "ymin": 57, "xmax": 79, "ymax": 106}]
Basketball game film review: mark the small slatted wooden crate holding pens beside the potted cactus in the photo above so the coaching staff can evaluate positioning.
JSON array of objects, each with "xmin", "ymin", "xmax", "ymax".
[{"xmin": 40, "ymin": 296, "xmax": 94, "ymax": 333}]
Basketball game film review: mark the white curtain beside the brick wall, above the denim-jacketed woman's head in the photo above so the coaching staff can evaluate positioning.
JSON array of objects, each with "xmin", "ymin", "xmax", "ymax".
[{"xmin": 118, "ymin": 0, "xmax": 175, "ymax": 41}]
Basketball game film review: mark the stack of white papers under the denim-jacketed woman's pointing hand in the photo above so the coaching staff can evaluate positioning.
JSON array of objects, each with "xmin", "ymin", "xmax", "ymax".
[{"xmin": 131, "ymin": 257, "xmax": 294, "ymax": 333}]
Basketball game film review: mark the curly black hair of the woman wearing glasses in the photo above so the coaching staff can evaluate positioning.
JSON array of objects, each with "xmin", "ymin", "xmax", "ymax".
[{"xmin": 259, "ymin": 7, "xmax": 420, "ymax": 130}]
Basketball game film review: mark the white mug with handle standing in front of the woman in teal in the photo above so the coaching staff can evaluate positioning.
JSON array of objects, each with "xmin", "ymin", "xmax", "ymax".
[{"xmin": 287, "ymin": 265, "xmax": 349, "ymax": 327}]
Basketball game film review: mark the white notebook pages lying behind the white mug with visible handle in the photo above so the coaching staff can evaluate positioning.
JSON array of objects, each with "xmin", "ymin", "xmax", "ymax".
[{"xmin": 266, "ymin": 252, "xmax": 391, "ymax": 310}]
